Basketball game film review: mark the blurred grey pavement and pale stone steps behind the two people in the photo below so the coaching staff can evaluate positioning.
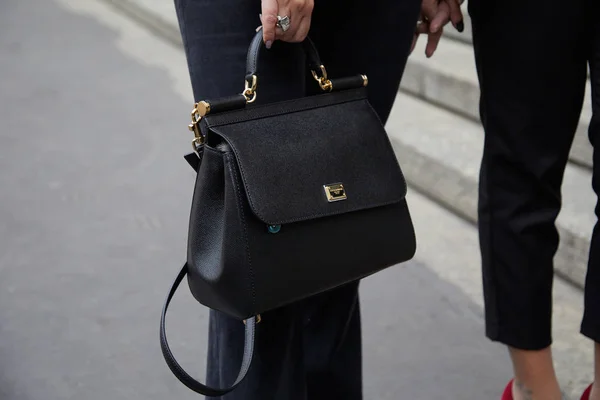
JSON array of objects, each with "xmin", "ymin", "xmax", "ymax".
[{"xmin": 0, "ymin": 0, "xmax": 595, "ymax": 400}]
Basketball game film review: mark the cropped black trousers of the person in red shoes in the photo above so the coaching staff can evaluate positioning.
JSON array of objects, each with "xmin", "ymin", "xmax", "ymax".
[{"xmin": 469, "ymin": 0, "xmax": 600, "ymax": 350}]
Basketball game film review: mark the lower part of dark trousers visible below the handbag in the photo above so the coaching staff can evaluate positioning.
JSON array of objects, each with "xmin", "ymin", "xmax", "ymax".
[{"xmin": 207, "ymin": 283, "xmax": 362, "ymax": 400}]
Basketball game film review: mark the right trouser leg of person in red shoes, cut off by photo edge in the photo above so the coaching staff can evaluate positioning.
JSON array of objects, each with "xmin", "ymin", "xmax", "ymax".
[{"xmin": 581, "ymin": 3, "xmax": 600, "ymax": 400}]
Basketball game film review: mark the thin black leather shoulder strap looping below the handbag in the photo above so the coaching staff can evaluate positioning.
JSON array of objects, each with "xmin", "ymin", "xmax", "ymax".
[{"xmin": 160, "ymin": 264, "xmax": 256, "ymax": 397}]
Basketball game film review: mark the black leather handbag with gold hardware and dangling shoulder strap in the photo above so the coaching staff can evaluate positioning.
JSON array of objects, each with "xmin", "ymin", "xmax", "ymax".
[{"xmin": 160, "ymin": 31, "xmax": 416, "ymax": 396}]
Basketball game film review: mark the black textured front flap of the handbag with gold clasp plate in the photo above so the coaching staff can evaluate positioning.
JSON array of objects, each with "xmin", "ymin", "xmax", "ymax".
[{"xmin": 208, "ymin": 94, "xmax": 406, "ymax": 225}]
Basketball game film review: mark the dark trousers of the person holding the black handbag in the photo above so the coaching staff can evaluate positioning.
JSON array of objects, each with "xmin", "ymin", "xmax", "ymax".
[{"xmin": 175, "ymin": 0, "xmax": 420, "ymax": 400}]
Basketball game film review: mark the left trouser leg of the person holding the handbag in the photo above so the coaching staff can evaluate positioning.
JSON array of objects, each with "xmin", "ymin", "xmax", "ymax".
[{"xmin": 175, "ymin": 0, "xmax": 306, "ymax": 400}]
